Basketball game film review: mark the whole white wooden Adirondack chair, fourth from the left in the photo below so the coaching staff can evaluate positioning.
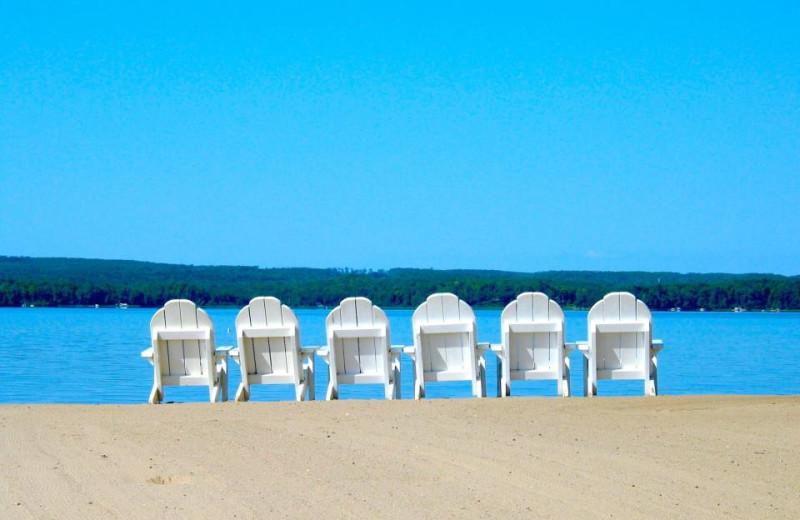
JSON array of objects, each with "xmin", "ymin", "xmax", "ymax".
[{"xmin": 405, "ymin": 293, "xmax": 488, "ymax": 399}]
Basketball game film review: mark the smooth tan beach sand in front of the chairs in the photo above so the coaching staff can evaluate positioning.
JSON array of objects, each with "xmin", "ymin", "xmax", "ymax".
[{"xmin": 0, "ymin": 396, "xmax": 800, "ymax": 519}]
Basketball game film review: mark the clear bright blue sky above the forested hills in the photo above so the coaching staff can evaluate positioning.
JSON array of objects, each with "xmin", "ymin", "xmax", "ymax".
[{"xmin": 0, "ymin": 1, "xmax": 800, "ymax": 274}]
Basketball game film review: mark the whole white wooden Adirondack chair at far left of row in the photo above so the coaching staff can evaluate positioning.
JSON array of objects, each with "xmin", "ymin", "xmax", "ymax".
[{"xmin": 142, "ymin": 300, "xmax": 228, "ymax": 404}]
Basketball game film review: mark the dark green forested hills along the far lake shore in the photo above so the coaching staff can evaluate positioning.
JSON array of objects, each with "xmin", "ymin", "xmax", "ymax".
[{"xmin": 0, "ymin": 256, "xmax": 800, "ymax": 310}]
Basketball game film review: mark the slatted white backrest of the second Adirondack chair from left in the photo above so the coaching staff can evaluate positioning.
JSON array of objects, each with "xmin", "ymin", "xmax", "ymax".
[{"xmin": 236, "ymin": 296, "xmax": 300, "ymax": 375}]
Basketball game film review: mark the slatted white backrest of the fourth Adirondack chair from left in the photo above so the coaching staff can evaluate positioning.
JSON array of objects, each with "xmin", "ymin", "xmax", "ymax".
[{"xmin": 411, "ymin": 293, "xmax": 477, "ymax": 372}]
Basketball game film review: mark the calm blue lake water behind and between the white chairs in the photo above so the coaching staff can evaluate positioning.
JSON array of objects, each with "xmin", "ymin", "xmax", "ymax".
[{"xmin": 0, "ymin": 308, "xmax": 800, "ymax": 403}]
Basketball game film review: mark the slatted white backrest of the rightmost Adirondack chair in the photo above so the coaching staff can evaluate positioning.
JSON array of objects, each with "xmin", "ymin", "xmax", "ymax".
[{"xmin": 587, "ymin": 292, "xmax": 653, "ymax": 370}]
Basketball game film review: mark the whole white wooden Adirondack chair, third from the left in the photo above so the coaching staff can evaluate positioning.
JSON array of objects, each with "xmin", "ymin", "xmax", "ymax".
[{"xmin": 317, "ymin": 297, "xmax": 402, "ymax": 400}]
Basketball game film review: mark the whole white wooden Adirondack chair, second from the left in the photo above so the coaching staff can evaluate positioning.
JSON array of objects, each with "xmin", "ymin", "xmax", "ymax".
[{"xmin": 231, "ymin": 296, "xmax": 315, "ymax": 401}]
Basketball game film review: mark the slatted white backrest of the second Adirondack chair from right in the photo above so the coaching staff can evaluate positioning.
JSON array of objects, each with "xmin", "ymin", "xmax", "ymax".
[{"xmin": 500, "ymin": 292, "xmax": 564, "ymax": 371}]
